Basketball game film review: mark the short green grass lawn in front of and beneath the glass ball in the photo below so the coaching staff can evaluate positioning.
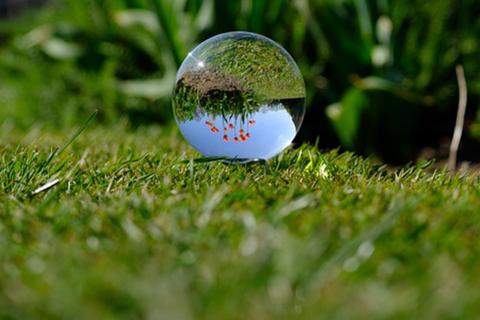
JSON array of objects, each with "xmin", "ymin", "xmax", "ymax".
[{"xmin": 0, "ymin": 123, "xmax": 480, "ymax": 319}]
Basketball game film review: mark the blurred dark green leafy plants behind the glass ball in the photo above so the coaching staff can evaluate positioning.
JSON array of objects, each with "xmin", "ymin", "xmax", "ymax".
[{"xmin": 0, "ymin": 0, "xmax": 480, "ymax": 164}]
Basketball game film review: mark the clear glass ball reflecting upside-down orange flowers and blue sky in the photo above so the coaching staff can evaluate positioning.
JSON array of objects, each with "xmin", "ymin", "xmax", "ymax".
[{"xmin": 173, "ymin": 32, "xmax": 305, "ymax": 162}]
